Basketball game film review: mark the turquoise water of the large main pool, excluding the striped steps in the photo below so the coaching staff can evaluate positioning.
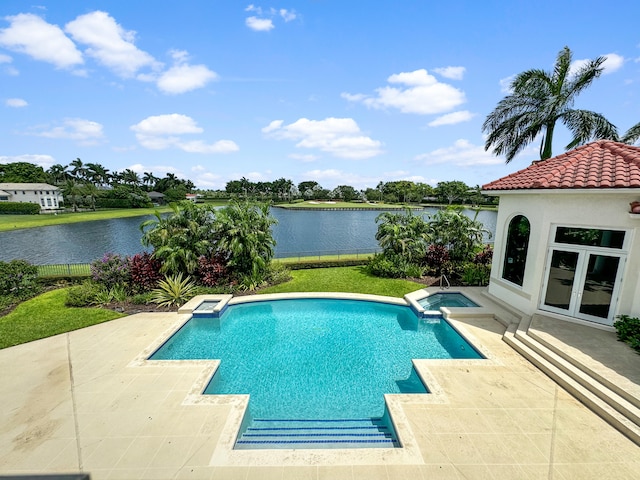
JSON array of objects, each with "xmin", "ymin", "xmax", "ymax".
[{"xmin": 151, "ymin": 299, "xmax": 481, "ymax": 419}]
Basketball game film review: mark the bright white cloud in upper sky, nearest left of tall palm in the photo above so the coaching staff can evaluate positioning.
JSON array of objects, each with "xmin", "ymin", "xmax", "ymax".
[{"xmin": 342, "ymin": 69, "xmax": 466, "ymax": 115}]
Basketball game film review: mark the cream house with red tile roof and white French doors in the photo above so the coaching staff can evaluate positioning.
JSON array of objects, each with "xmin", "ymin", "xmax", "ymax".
[{"xmin": 482, "ymin": 140, "xmax": 640, "ymax": 329}]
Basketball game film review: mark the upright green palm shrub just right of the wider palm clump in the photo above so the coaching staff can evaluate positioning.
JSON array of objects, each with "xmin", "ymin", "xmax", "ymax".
[{"xmin": 213, "ymin": 201, "xmax": 277, "ymax": 290}]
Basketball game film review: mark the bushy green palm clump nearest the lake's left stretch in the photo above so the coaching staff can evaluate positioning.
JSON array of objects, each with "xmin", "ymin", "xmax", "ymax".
[{"xmin": 140, "ymin": 201, "xmax": 217, "ymax": 274}]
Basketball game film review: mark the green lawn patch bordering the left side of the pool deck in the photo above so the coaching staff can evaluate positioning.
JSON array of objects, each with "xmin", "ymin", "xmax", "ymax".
[{"xmin": 0, "ymin": 288, "xmax": 124, "ymax": 348}]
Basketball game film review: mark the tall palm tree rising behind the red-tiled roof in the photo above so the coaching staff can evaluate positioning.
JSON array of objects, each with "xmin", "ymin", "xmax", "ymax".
[{"xmin": 482, "ymin": 47, "xmax": 618, "ymax": 163}]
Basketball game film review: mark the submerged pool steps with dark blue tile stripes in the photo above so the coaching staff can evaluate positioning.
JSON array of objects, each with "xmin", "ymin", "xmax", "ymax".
[{"xmin": 235, "ymin": 418, "xmax": 400, "ymax": 449}]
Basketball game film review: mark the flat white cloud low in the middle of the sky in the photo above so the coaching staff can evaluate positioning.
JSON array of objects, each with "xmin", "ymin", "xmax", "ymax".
[{"xmin": 262, "ymin": 118, "xmax": 383, "ymax": 159}]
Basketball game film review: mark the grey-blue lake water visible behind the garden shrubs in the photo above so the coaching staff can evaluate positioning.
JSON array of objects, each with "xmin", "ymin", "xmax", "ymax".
[{"xmin": 0, "ymin": 208, "xmax": 497, "ymax": 265}]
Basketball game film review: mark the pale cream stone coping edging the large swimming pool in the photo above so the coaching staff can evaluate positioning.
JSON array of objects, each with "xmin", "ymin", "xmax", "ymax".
[{"xmin": 128, "ymin": 289, "xmax": 502, "ymax": 466}]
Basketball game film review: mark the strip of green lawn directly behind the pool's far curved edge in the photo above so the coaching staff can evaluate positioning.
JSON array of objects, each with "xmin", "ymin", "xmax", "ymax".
[{"xmin": 259, "ymin": 266, "xmax": 424, "ymax": 297}]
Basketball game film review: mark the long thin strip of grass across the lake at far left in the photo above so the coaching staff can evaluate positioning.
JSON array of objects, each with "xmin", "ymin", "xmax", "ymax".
[{"xmin": 0, "ymin": 207, "xmax": 170, "ymax": 232}]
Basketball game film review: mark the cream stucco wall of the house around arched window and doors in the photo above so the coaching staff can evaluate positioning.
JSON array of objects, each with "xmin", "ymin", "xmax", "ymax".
[{"xmin": 489, "ymin": 190, "xmax": 640, "ymax": 322}]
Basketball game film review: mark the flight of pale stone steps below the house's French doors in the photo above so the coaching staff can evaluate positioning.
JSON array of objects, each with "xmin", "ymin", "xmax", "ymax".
[{"xmin": 503, "ymin": 324, "xmax": 640, "ymax": 445}]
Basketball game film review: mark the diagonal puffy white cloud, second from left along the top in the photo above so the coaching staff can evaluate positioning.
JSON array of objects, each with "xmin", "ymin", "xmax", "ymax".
[{"xmin": 65, "ymin": 11, "xmax": 160, "ymax": 77}]
